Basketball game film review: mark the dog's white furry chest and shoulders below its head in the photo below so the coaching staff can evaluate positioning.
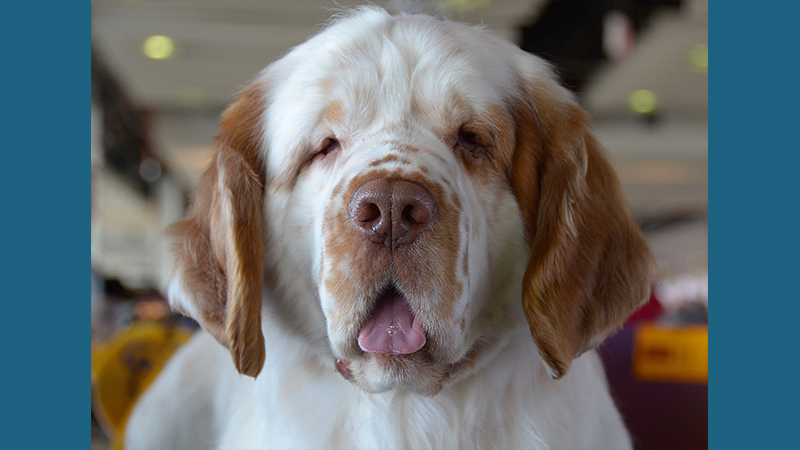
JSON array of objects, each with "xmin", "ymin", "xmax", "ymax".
[{"xmin": 126, "ymin": 327, "xmax": 631, "ymax": 450}]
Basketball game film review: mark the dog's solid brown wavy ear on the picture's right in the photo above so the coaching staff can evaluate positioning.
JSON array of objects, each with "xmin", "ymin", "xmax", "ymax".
[{"xmin": 511, "ymin": 61, "xmax": 655, "ymax": 379}]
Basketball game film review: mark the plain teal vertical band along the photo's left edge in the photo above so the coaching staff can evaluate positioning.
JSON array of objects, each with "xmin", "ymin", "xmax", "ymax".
[{"xmin": 5, "ymin": 1, "xmax": 86, "ymax": 449}]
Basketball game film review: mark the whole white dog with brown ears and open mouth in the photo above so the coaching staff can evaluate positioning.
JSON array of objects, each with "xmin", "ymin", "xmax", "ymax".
[{"xmin": 126, "ymin": 7, "xmax": 655, "ymax": 449}]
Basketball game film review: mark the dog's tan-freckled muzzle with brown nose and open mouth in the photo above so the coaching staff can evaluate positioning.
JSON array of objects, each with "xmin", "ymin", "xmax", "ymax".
[{"xmin": 322, "ymin": 169, "xmax": 465, "ymax": 395}]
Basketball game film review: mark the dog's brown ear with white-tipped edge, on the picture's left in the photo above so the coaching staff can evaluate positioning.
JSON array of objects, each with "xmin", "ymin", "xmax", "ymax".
[{"xmin": 168, "ymin": 83, "xmax": 267, "ymax": 378}]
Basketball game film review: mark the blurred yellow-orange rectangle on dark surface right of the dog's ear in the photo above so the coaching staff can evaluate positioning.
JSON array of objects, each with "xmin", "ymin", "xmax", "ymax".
[{"xmin": 632, "ymin": 323, "xmax": 708, "ymax": 384}]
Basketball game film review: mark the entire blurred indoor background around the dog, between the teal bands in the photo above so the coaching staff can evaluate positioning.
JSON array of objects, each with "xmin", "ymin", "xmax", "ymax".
[{"xmin": 91, "ymin": 0, "xmax": 708, "ymax": 449}]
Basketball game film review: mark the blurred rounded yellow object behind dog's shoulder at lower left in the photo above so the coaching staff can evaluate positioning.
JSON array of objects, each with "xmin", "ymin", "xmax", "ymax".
[{"xmin": 92, "ymin": 322, "xmax": 192, "ymax": 449}]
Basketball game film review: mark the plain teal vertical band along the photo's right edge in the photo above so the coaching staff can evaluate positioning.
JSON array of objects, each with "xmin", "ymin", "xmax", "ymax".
[{"xmin": 709, "ymin": 1, "xmax": 800, "ymax": 449}]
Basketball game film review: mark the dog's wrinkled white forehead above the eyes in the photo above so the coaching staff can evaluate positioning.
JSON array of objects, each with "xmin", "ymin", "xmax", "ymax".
[{"xmin": 267, "ymin": 13, "xmax": 517, "ymax": 163}]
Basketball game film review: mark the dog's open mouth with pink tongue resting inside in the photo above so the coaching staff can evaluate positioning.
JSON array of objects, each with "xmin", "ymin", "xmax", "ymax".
[{"xmin": 358, "ymin": 292, "xmax": 425, "ymax": 355}]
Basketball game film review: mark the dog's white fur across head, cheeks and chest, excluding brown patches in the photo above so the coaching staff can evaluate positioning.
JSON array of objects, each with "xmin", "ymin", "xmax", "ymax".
[{"xmin": 126, "ymin": 8, "xmax": 631, "ymax": 450}]
